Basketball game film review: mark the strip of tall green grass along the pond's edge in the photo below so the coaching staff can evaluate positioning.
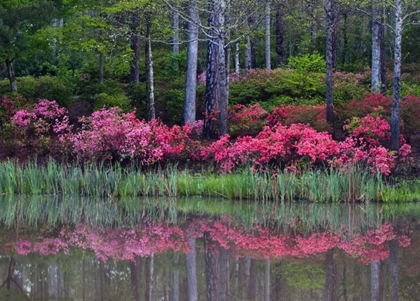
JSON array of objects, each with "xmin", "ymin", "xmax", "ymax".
[{"xmin": 0, "ymin": 160, "xmax": 420, "ymax": 203}]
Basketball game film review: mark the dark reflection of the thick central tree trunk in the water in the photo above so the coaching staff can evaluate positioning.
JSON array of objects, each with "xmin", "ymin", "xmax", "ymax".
[{"xmin": 204, "ymin": 231, "xmax": 220, "ymax": 301}]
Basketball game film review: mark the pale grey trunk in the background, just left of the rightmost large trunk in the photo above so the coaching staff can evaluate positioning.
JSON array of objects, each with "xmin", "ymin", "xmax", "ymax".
[{"xmin": 371, "ymin": 0, "xmax": 382, "ymax": 92}]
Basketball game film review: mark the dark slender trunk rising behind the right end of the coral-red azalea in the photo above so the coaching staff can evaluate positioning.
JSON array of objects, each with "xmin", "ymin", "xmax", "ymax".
[{"xmin": 325, "ymin": 0, "xmax": 336, "ymax": 134}]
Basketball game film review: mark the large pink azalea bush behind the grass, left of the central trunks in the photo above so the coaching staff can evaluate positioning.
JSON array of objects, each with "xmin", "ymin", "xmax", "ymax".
[{"xmin": 71, "ymin": 108, "xmax": 200, "ymax": 165}]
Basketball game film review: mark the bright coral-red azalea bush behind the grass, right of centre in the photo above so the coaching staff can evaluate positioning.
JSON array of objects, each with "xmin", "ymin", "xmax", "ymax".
[{"xmin": 202, "ymin": 124, "xmax": 339, "ymax": 172}]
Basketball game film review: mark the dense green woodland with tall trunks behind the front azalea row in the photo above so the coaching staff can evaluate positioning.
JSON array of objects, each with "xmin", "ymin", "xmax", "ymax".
[{"xmin": 0, "ymin": 0, "xmax": 420, "ymax": 178}]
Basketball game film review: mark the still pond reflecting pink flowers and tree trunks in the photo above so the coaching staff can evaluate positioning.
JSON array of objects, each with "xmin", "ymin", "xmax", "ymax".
[{"xmin": 0, "ymin": 196, "xmax": 420, "ymax": 301}]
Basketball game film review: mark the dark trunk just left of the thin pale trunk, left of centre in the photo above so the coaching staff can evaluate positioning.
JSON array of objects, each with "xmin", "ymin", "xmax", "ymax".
[{"xmin": 130, "ymin": 11, "xmax": 140, "ymax": 84}]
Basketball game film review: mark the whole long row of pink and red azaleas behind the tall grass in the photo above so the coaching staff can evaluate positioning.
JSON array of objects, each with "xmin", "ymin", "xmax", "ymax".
[{"xmin": 3, "ymin": 99, "xmax": 411, "ymax": 175}]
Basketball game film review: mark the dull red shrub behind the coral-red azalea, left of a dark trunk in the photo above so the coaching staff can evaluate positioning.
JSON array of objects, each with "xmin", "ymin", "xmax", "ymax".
[{"xmin": 266, "ymin": 105, "xmax": 331, "ymax": 132}]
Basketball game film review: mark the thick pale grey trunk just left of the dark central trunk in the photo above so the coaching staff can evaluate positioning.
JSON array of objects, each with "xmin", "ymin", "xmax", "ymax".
[{"xmin": 183, "ymin": 0, "xmax": 200, "ymax": 124}]
